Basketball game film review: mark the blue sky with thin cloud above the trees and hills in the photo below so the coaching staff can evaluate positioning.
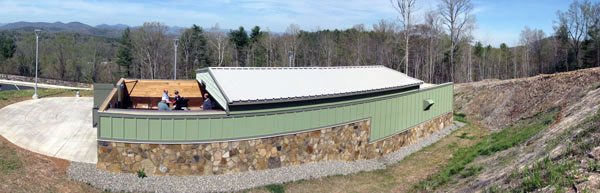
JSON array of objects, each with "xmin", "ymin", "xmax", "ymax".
[{"xmin": 0, "ymin": 0, "xmax": 572, "ymax": 47}]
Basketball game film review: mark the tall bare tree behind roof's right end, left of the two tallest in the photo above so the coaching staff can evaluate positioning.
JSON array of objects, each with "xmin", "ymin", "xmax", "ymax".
[{"xmin": 390, "ymin": 0, "xmax": 416, "ymax": 75}]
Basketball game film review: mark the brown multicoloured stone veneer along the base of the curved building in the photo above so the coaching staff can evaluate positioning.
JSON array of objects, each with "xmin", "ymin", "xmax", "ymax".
[{"xmin": 97, "ymin": 113, "xmax": 453, "ymax": 175}]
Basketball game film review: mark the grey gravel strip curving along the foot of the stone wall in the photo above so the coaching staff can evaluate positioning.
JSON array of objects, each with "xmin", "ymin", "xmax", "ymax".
[{"xmin": 67, "ymin": 121, "xmax": 464, "ymax": 192}]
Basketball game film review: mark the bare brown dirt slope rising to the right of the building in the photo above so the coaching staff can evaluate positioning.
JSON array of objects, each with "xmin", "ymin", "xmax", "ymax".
[{"xmin": 448, "ymin": 68, "xmax": 600, "ymax": 192}]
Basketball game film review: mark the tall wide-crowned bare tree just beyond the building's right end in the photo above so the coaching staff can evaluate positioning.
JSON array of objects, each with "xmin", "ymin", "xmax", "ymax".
[{"xmin": 438, "ymin": 0, "xmax": 475, "ymax": 81}]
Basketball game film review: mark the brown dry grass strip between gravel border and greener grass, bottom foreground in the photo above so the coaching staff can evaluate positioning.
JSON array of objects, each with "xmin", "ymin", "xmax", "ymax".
[{"xmin": 248, "ymin": 121, "xmax": 488, "ymax": 193}]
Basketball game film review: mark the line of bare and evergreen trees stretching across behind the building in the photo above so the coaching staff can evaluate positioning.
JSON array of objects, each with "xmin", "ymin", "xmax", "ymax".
[{"xmin": 0, "ymin": 0, "xmax": 600, "ymax": 83}]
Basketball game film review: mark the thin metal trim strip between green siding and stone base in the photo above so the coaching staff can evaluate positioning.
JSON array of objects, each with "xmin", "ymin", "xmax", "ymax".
[{"xmin": 97, "ymin": 117, "xmax": 371, "ymax": 144}]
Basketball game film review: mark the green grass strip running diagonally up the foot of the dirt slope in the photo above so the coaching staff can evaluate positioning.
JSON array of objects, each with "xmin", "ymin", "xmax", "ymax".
[{"xmin": 413, "ymin": 108, "xmax": 559, "ymax": 192}]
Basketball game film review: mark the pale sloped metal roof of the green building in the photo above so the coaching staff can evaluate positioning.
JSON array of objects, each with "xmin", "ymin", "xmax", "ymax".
[{"xmin": 199, "ymin": 66, "xmax": 423, "ymax": 105}]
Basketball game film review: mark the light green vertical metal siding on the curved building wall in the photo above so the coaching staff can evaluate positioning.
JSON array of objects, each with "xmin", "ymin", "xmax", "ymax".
[{"xmin": 98, "ymin": 84, "xmax": 453, "ymax": 142}]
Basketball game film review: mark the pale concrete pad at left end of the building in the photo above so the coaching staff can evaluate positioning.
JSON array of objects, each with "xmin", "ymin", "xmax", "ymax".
[{"xmin": 0, "ymin": 97, "xmax": 97, "ymax": 164}]
